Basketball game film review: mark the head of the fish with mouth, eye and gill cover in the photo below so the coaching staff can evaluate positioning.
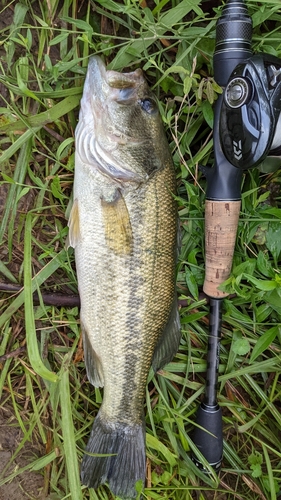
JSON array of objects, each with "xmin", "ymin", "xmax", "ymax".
[{"xmin": 76, "ymin": 56, "xmax": 170, "ymax": 184}]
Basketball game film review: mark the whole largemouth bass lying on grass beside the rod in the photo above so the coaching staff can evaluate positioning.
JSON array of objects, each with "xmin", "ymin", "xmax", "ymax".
[{"xmin": 68, "ymin": 56, "xmax": 180, "ymax": 500}]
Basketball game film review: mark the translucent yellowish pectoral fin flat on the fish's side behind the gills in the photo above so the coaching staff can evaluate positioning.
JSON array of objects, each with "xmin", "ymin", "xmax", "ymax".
[{"xmin": 101, "ymin": 190, "xmax": 133, "ymax": 255}]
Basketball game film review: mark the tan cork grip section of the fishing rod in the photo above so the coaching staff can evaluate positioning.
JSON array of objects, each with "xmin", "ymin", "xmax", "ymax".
[{"xmin": 203, "ymin": 200, "xmax": 241, "ymax": 298}]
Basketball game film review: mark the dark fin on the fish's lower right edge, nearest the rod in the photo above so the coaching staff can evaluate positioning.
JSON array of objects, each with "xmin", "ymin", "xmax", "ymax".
[{"xmin": 152, "ymin": 294, "xmax": 181, "ymax": 372}]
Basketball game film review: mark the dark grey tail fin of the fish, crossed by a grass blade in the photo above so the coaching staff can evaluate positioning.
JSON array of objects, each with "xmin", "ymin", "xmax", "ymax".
[{"xmin": 81, "ymin": 415, "xmax": 146, "ymax": 500}]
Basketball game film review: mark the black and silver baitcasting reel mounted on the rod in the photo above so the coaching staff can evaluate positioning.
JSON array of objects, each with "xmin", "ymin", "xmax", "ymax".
[{"xmin": 219, "ymin": 54, "xmax": 281, "ymax": 169}]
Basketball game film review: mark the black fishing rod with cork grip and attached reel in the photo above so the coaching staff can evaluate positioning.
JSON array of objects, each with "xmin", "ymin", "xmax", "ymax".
[{"xmin": 192, "ymin": 0, "xmax": 281, "ymax": 472}]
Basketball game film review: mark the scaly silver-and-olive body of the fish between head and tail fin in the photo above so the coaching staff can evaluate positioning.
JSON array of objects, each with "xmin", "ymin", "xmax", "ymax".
[{"xmin": 74, "ymin": 172, "xmax": 176, "ymax": 420}]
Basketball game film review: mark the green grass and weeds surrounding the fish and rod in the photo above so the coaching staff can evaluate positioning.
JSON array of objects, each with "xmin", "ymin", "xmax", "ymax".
[{"xmin": 0, "ymin": 0, "xmax": 281, "ymax": 500}]
